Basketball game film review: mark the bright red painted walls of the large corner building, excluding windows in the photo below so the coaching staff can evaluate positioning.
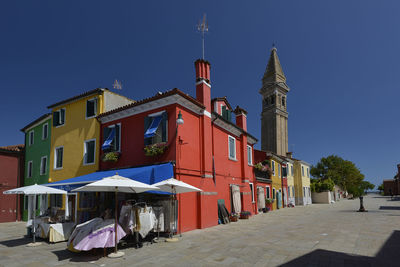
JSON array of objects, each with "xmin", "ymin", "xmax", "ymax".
[{"xmin": 100, "ymin": 104, "xmax": 256, "ymax": 232}]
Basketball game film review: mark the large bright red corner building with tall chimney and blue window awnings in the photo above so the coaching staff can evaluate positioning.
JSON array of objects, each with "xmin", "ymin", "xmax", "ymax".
[{"xmin": 98, "ymin": 60, "xmax": 257, "ymax": 232}]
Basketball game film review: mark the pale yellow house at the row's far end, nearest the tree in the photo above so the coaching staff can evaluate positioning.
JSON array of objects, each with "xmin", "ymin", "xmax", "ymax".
[{"xmin": 294, "ymin": 160, "xmax": 312, "ymax": 205}]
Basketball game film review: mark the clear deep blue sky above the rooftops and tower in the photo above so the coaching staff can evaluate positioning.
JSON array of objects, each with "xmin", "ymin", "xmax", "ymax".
[{"xmin": 0, "ymin": 0, "xmax": 400, "ymax": 187}]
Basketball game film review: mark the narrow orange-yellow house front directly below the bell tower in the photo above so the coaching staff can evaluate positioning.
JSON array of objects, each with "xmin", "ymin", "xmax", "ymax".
[{"xmin": 267, "ymin": 152, "xmax": 283, "ymax": 210}]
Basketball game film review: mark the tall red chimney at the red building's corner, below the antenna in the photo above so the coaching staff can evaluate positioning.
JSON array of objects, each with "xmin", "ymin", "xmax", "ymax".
[{"xmin": 194, "ymin": 59, "xmax": 211, "ymax": 113}]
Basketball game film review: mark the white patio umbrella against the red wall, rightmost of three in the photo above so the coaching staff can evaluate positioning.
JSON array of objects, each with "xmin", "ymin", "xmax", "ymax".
[{"xmin": 153, "ymin": 178, "xmax": 202, "ymax": 242}]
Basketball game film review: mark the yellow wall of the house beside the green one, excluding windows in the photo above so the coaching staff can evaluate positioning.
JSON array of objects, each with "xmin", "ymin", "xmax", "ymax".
[{"xmin": 49, "ymin": 95, "xmax": 103, "ymax": 182}]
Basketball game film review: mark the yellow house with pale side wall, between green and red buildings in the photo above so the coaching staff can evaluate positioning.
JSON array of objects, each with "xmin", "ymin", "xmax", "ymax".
[{"xmin": 48, "ymin": 88, "xmax": 133, "ymax": 182}]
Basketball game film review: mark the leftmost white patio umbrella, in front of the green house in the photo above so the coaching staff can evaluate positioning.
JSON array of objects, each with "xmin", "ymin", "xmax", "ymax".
[{"xmin": 3, "ymin": 184, "xmax": 67, "ymax": 246}]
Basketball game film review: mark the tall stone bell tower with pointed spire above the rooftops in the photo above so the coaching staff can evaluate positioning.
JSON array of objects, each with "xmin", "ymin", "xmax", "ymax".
[{"xmin": 259, "ymin": 47, "xmax": 290, "ymax": 156}]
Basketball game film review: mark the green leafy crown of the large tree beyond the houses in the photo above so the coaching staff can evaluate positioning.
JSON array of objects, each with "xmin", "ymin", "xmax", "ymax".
[{"xmin": 310, "ymin": 155, "xmax": 375, "ymax": 197}]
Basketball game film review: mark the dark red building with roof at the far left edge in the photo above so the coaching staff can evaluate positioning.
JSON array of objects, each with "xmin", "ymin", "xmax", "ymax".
[{"xmin": 0, "ymin": 145, "xmax": 24, "ymax": 223}]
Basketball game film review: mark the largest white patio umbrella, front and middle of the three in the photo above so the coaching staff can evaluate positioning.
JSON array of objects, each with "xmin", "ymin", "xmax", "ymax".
[{"xmin": 72, "ymin": 174, "xmax": 160, "ymax": 258}]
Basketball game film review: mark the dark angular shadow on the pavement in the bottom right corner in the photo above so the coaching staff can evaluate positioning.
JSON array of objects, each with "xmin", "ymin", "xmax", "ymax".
[{"xmin": 280, "ymin": 231, "xmax": 400, "ymax": 267}]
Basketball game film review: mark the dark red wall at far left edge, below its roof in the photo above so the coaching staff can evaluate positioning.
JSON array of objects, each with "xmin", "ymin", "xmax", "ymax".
[{"xmin": 0, "ymin": 154, "xmax": 21, "ymax": 222}]
